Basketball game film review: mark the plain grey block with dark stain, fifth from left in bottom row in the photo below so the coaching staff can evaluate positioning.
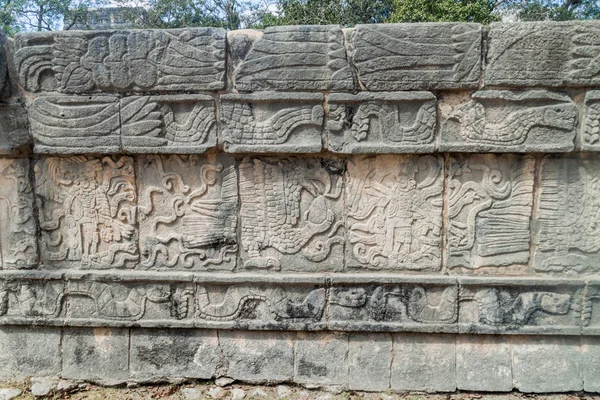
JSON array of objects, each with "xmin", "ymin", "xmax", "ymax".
[{"xmin": 294, "ymin": 333, "xmax": 348, "ymax": 387}]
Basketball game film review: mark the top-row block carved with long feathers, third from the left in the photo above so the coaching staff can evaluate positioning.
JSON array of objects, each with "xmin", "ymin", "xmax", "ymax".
[{"xmin": 351, "ymin": 23, "xmax": 482, "ymax": 91}]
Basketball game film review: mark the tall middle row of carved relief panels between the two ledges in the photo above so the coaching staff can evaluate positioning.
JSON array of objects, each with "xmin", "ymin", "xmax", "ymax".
[{"xmin": 0, "ymin": 153, "xmax": 600, "ymax": 276}]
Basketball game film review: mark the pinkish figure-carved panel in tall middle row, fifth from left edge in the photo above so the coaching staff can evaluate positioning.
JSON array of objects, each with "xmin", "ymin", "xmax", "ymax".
[{"xmin": 345, "ymin": 155, "xmax": 443, "ymax": 271}]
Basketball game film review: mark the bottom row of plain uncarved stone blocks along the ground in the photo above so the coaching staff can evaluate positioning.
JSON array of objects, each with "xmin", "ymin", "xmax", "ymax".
[{"xmin": 0, "ymin": 327, "xmax": 600, "ymax": 393}]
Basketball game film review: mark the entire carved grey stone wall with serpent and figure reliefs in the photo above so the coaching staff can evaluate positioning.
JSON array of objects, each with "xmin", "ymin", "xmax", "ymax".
[{"xmin": 0, "ymin": 22, "xmax": 600, "ymax": 392}]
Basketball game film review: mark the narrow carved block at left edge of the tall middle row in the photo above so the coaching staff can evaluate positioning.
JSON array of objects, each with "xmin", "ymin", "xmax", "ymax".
[{"xmin": 0, "ymin": 158, "xmax": 38, "ymax": 269}]
